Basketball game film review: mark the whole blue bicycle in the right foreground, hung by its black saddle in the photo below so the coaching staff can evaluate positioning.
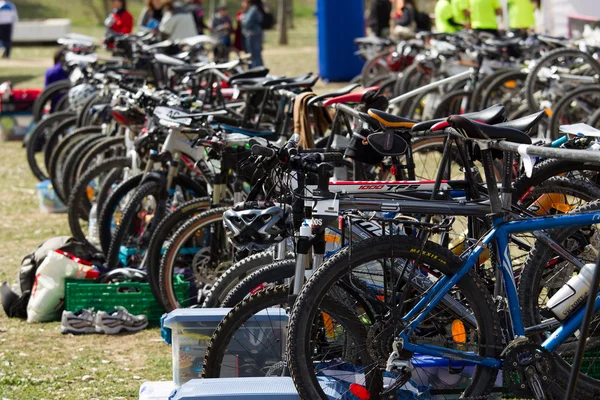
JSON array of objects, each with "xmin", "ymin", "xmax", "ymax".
[{"xmin": 287, "ymin": 116, "xmax": 600, "ymax": 400}]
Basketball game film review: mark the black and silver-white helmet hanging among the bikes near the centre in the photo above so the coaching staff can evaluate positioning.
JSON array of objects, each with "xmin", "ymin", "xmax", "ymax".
[{"xmin": 223, "ymin": 202, "xmax": 293, "ymax": 250}]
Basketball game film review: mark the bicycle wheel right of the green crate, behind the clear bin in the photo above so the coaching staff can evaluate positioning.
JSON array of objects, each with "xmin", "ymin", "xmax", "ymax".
[{"xmin": 159, "ymin": 207, "xmax": 234, "ymax": 311}]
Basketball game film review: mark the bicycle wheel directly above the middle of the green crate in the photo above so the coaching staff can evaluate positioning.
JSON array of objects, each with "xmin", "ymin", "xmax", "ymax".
[{"xmin": 106, "ymin": 175, "xmax": 206, "ymax": 268}]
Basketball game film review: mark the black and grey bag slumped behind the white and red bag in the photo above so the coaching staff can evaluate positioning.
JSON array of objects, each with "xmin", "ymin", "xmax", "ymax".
[{"xmin": 0, "ymin": 236, "xmax": 104, "ymax": 319}]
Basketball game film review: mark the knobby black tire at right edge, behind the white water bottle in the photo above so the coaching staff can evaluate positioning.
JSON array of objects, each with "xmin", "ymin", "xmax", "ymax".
[{"xmin": 518, "ymin": 201, "xmax": 600, "ymax": 399}]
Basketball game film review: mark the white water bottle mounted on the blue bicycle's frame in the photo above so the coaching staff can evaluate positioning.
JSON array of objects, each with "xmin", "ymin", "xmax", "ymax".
[{"xmin": 548, "ymin": 264, "xmax": 596, "ymax": 321}]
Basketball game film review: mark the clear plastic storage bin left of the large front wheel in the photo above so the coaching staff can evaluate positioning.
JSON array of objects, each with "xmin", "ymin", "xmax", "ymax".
[{"xmin": 163, "ymin": 308, "xmax": 288, "ymax": 386}]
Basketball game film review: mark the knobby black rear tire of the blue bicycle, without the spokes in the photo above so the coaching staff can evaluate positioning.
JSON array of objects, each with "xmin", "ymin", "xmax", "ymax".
[{"xmin": 287, "ymin": 236, "xmax": 501, "ymax": 399}]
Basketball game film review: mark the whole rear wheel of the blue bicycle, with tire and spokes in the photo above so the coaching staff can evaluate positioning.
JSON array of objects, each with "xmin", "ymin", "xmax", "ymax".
[{"xmin": 287, "ymin": 236, "xmax": 501, "ymax": 399}]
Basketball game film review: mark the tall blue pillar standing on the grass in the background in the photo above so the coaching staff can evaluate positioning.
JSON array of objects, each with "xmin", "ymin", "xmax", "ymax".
[{"xmin": 317, "ymin": 0, "xmax": 365, "ymax": 82}]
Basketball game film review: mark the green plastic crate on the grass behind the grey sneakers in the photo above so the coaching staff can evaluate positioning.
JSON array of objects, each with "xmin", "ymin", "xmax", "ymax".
[{"xmin": 65, "ymin": 280, "xmax": 190, "ymax": 325}]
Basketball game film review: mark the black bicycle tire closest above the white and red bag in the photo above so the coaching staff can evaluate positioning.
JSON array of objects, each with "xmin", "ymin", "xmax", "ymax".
[{"xmin": 68, "ymin": 157, "xmax": 131, "ymax": 247}]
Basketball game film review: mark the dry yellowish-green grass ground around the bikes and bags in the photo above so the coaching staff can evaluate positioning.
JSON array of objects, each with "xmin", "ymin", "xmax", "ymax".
[{"xmin": 0, "ymin": 14, "xmax": 346, "ymax": 400}]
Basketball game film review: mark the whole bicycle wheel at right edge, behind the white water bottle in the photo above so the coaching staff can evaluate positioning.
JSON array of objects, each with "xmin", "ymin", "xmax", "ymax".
[{"xmin": 519, "ymin": 201, "xmax": 600, "ymax": 399}]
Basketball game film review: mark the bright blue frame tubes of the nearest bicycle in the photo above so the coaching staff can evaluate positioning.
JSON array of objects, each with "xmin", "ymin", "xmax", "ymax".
[{"xmin": 399, "ymin": 213, "xmax": 600, "ymax": 368}]
